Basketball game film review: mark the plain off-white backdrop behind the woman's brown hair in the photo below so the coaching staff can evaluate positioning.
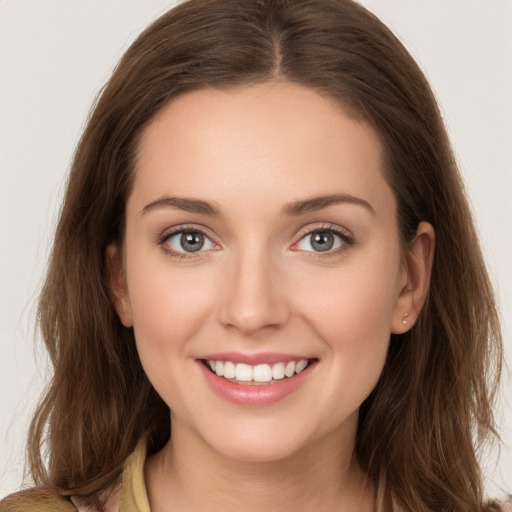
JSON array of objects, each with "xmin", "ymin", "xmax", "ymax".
[{"xmin": 0, "ymin": 0, "xmax": 512, "ymax": 496}]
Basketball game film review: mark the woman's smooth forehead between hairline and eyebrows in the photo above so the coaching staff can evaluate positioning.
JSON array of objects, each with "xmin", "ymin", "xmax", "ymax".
[{"xmin": 132, "ymin": 82, "xmax": 393, "ymax": 216}]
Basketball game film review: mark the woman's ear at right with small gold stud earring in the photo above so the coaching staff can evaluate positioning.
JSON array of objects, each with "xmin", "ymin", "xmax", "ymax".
[{"xmin": 391, "ymin": 222, "xmax": 436, "ymax": 334}]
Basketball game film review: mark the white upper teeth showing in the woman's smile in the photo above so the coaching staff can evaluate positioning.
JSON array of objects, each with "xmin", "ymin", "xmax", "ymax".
[{"xmin": 208, "ymin": 359, "xmax": 308, "ymax": 382}]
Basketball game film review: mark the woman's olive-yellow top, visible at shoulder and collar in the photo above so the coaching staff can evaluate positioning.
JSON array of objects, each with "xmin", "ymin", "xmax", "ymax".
[{"xmin": 0, "ymin": 442, "xmax": 150, "ymax": 512}]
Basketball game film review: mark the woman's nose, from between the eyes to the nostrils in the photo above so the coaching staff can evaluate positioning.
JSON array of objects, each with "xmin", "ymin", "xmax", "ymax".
[{"xmin": 219, "ymin": 247, "xmax": 290, "ymax": 335}]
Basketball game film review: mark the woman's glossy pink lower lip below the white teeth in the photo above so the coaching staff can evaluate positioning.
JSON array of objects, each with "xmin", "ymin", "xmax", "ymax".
[{"xmin": 198, "ymin": 361, "xmax": 316, "ymax": 407}]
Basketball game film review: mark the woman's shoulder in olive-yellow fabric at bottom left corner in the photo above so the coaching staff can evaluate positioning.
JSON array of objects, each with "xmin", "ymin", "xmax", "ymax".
[{"xmin": 0, "ymin": 488, "xmax": 76, "ymax": 512}]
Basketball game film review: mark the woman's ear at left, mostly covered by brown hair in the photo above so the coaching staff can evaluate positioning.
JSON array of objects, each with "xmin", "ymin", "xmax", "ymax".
[{"xmin": 106, "ymin": 243, "xmax": 133, "ymax": 327}]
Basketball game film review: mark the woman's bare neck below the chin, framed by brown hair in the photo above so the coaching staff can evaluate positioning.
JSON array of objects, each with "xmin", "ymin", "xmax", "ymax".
[{"xmin": 145, "ymin": 418, "xmax": 375, "ymax": 512}]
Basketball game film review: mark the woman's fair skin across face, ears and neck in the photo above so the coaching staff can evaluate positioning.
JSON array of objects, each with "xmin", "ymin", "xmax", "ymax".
[{"xmin": 108, "ymin": 82, "xmax": 434, "ymax": 512}]
